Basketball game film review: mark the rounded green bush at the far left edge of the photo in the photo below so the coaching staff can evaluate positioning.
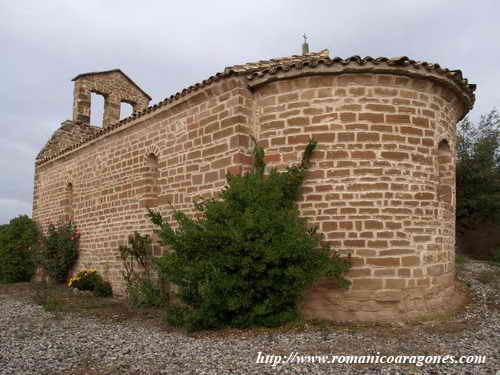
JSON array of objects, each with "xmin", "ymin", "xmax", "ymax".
[{"xmin": 0, "ymin": 215, "xmax": 40, "ymax": 283}]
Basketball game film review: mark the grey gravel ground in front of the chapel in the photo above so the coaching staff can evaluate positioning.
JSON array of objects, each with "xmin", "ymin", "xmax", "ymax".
[{"xmin": 0, "ymin": 262, "xmax": 500, "ymax": 375}]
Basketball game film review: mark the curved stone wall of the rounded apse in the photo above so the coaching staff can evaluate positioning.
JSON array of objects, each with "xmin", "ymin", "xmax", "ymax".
[{"xmin": 252, "ymin": 74, "xmax": 463, "ymax": 320}]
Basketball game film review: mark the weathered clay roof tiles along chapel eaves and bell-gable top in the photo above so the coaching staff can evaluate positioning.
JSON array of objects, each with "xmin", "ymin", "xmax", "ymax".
[{"xmin": 37, "ymin": 49, "xmax": 476, "ymax": 164}]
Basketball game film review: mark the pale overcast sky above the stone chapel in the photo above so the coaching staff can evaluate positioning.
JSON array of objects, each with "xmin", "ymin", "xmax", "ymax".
[{"xmin": 0, "ymin": 0, "xmax": 500, "ymax": 224}]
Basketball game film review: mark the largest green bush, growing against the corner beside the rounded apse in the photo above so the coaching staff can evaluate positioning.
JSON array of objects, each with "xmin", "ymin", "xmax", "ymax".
[{"xmin": 148, "ymin": 140, "xmax": 350, "ymax": 330}]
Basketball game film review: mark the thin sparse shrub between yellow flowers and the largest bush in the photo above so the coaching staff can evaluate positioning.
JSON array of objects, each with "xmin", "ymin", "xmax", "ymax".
[{"xmin": 119, "ymin": 232, "xmax": 164, "ymax": 308}]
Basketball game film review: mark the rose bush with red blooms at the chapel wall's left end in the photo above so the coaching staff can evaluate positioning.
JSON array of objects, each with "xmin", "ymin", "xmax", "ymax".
[{"xmin": 39, "ymin": 222, "xmax": 80, "ymax": 283}]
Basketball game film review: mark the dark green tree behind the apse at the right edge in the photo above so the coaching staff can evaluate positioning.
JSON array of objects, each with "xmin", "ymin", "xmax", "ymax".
[{"xmin": 456, "ymin": 110, "xmax": 500, "ymax": 231}]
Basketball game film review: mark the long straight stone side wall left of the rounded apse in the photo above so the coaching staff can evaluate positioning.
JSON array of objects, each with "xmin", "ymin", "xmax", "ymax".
[{"xmin": 33, "ymin": 75, "xmax": 251, "ymax": 289}]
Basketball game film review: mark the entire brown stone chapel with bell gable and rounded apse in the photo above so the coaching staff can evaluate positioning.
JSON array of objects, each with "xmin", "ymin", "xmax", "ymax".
[{"xmin": 33, "ymin": 50, "xmax": 475, "ymax": 320}]
